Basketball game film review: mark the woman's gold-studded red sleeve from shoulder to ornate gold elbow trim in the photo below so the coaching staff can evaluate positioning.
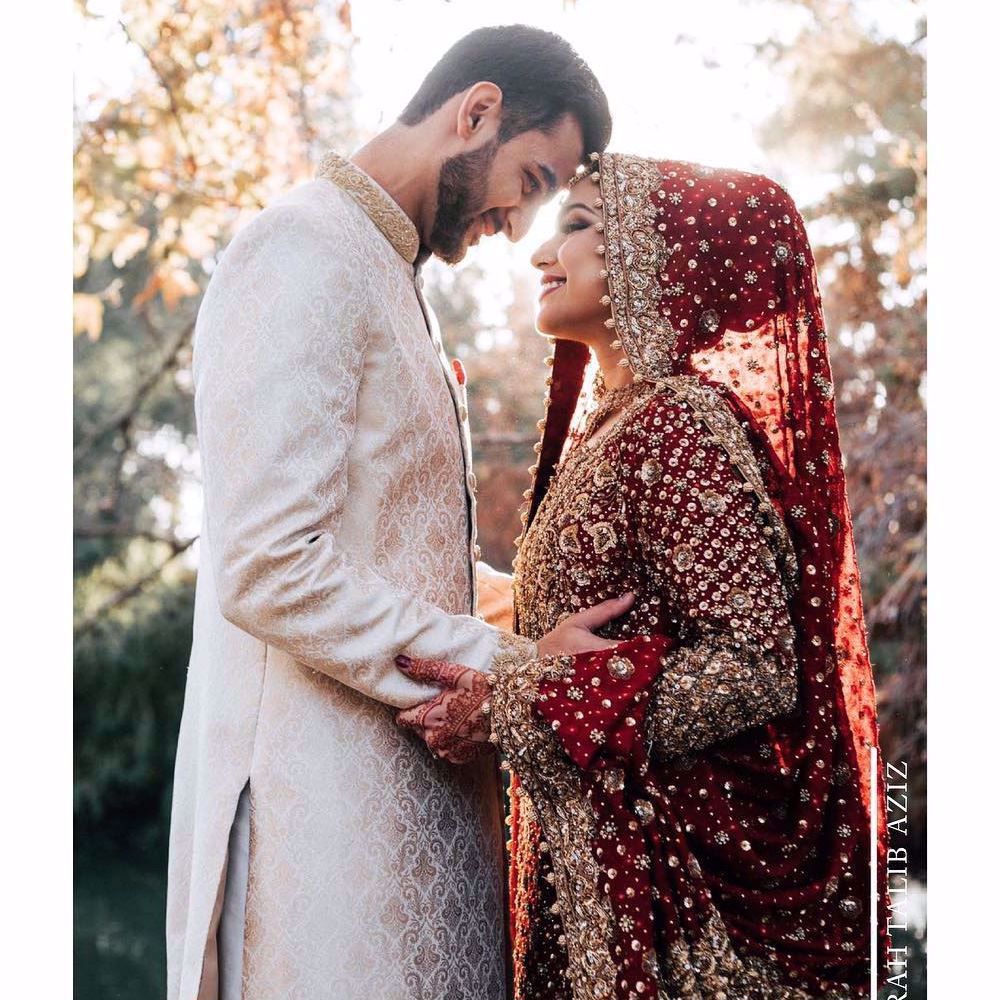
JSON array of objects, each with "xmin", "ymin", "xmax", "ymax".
[{"xmin": 620, "ymin": 394, "xmax": 798, "ymax": 757}]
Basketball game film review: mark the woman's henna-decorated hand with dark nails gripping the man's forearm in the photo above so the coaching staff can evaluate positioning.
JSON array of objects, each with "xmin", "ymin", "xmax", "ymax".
[{"xmin": 396, "ymin": 656, "xmax": 493, "ymax": 764}]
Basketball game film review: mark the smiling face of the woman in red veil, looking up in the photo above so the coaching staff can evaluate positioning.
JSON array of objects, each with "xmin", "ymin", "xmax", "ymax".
[{"xmin": 531, "ymin": 178, "xmax": 612, "ymax": 346}]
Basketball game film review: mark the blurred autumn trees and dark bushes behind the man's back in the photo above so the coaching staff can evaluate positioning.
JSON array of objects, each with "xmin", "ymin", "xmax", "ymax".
[{"xmin": 74, "ymin": 0, "xmax": 353, "ymax": 847}]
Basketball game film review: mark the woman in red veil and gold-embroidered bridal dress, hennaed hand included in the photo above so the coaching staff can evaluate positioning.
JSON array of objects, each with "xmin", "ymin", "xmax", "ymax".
[{"xmin": 399, "ymin": 154, "xmax": 887, "ymax": 1000}]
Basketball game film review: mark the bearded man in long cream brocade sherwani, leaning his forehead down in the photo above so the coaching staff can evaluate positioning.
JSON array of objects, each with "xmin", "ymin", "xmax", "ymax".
[{"xmin": 167, "ymin": 26, "xmax": 622, "ymax": 1000}]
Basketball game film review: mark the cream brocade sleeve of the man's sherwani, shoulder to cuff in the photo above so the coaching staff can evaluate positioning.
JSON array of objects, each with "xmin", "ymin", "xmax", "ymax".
[{"xmin": 194, "ymin": 203, "xmax": 533, "ymax": 707}]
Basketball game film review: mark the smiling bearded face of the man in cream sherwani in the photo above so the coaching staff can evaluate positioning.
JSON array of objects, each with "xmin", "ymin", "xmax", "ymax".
[{"xmin": 427, "ymin": 115, "xmax": 583, "ymax": 264}]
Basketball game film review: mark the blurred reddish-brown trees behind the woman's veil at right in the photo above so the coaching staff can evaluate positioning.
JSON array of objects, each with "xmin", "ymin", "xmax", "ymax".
[{"xmin": 759, "ymin": 0, "xmax": 927, "ymax": 871}]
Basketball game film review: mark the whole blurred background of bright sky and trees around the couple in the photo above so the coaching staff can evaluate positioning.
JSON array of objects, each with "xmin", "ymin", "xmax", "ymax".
[{"xmin": 74, "ymin": 0, "xmax": 926, "ymax": 1000}]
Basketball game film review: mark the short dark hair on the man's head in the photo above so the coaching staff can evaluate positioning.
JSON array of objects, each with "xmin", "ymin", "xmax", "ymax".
[{"xmin": 399, "ymin": 24, "xmax": 611, "ymax": 153}]
